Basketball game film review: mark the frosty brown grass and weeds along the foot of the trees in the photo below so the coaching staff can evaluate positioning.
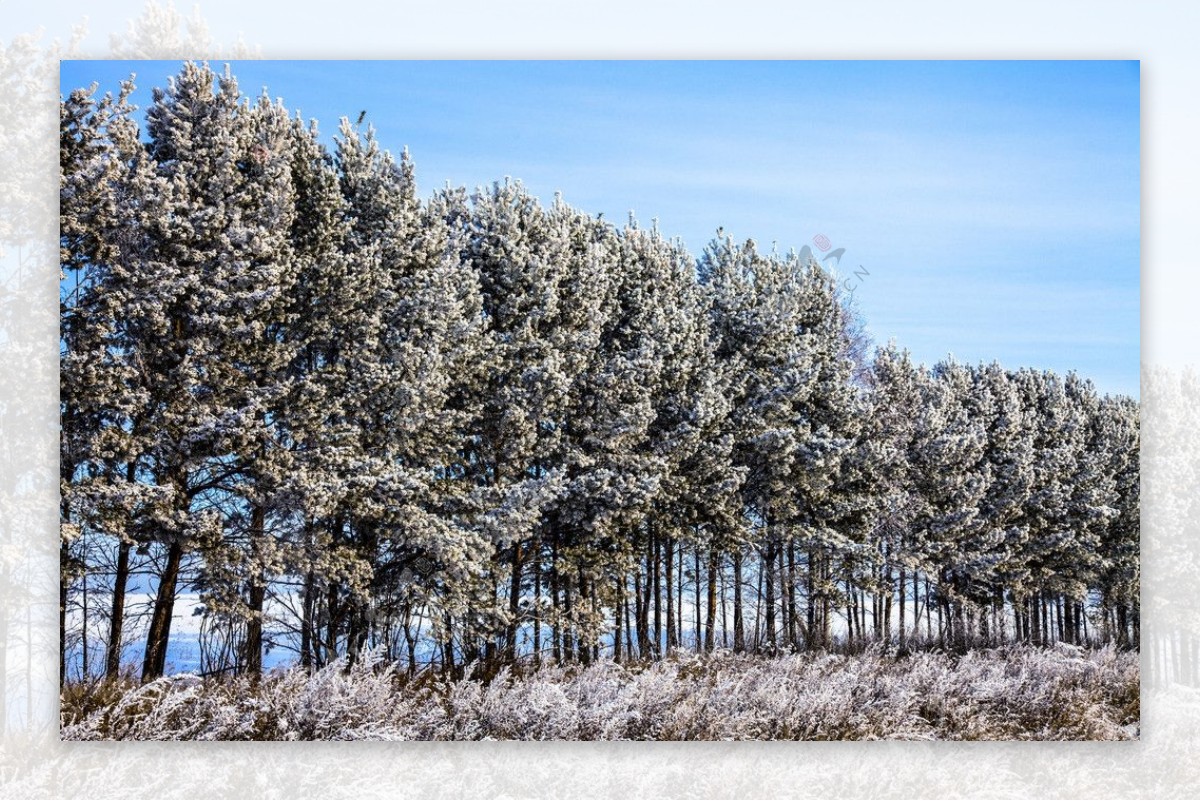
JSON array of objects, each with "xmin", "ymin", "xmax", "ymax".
[{"xmin": 61, "ymin": 646, "xmax": 1140, "ymax": 740}]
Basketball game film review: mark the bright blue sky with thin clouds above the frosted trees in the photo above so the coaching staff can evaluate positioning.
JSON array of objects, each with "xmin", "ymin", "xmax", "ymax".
[{"xmin": 61, "ymin": 61, "xmax": 1140, "ymax": 395}]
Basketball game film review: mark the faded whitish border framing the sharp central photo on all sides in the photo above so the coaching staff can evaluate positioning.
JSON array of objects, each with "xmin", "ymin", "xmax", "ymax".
[{"xmin": 0, "ymin": 2, "xmax": 1200, "ymax": 797}]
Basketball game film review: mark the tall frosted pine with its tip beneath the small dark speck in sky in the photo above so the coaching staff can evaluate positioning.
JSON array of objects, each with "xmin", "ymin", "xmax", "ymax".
[{"xmin": 329, "ymin": 120, "xmax": 488, "ymax": 671}]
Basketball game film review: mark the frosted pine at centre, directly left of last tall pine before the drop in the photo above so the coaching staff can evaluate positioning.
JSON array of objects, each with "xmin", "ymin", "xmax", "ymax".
[{"xmin": 558, "ymin": 219, "xmax": 727, "ymax": 655}]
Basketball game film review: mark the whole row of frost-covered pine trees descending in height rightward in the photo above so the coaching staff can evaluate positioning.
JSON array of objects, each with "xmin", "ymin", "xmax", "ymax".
[{"xmin": 60, "ymin": 64, "xmax": 1139, "ymax": 680}]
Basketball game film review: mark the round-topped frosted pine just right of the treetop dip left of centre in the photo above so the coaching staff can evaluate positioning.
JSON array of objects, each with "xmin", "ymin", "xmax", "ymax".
[{"xmin": 460, "ymin": 181, "xmax": 595, "ymax": 657}]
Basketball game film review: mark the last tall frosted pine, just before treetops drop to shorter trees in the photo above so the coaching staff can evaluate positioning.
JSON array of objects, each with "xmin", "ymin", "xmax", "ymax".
[{"xmin": 700, "ymin": 239, "xmax": 866, "ymax": 650}]
